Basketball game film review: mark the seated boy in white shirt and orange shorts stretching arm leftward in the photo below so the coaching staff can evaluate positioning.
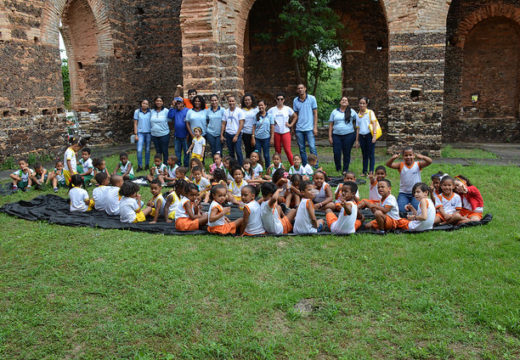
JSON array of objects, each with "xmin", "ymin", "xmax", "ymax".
[{"xmin": 358, "ymin": 179, "xmax": 408, "ymax": 234}]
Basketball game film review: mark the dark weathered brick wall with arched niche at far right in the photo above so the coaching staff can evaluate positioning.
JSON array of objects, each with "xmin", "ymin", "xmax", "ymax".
[{"xmin": 442, "ymin": 0, "xmax": 520, "ymax": 142}]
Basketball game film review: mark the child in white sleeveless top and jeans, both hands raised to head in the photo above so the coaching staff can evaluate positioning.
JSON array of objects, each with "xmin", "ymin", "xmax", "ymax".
[{"xmin": 386, "ymin": 146, "xmax": 433, "ymax": 213}]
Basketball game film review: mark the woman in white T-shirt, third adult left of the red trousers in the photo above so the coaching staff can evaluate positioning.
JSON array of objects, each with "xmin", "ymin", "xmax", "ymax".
[{"xmin": 220, "ymin": 95, "xmax": 245, "ymax": 165}]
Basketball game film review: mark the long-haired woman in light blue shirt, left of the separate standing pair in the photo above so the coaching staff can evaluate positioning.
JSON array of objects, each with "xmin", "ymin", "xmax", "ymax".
[{"xmin": 329, "ymin": 96, "xmax": 356, "ymax": 172}]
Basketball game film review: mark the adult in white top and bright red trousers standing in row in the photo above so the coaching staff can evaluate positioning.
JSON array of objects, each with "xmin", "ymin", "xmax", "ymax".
[{"xmin": 269, "ymin": 93, "xmax": 296, "ymax": 166}]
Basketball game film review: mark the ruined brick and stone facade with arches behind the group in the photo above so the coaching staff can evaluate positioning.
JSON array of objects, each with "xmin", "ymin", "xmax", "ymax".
[{"xmin": 0, "ymin": 0, "xmax": 520, "ymax": 161}]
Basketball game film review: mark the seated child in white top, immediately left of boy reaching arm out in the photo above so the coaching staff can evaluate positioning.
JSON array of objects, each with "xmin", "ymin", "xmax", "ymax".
[{"xmin": 325, "ymin": 181, "xmax": 361, "ymax": 234}]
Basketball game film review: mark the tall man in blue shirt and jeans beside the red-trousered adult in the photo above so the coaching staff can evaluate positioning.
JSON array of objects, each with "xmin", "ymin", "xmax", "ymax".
[{"xmin": 293, "ymin": 84, "xmax": 318, "ymax": 167}]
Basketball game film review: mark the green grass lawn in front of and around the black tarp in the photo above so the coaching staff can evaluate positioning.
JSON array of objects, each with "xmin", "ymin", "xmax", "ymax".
[{"xmin": 0, "ymin": 149, "xmax": 520, "ymax": 359}]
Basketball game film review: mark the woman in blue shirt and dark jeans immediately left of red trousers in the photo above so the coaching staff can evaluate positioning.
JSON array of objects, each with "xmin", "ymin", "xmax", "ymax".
[{"xmin": 251, "ymin": 100, "xmax": 274, "ymax": 169}]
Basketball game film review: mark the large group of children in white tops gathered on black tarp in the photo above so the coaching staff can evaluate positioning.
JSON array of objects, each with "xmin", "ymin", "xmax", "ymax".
[{"xmin": 12, "ymin": 136, "xmax": 484, "ymax": 235}]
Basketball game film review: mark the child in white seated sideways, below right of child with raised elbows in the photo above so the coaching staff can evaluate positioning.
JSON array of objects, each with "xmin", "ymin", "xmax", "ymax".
[{"xmin": 406, "ymin": 183, "xmax": 435, "ymax": 231}]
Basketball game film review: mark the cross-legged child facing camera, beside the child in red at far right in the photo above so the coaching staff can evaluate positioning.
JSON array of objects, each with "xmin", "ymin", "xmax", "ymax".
[{"xmin": 435, "ymin": 176, "xmax": 468, "ymax": 225}]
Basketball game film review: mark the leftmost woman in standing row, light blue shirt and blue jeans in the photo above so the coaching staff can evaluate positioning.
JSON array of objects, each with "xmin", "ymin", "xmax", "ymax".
[{"xmin": 134, "ymin": 100, "xmax": 152, "ymax": 171}]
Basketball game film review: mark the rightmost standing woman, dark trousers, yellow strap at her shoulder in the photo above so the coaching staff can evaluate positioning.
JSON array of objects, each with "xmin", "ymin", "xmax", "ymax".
[{"xmin": 356, "ymin": 97, "xmax": 378, "ymax": 176}]
